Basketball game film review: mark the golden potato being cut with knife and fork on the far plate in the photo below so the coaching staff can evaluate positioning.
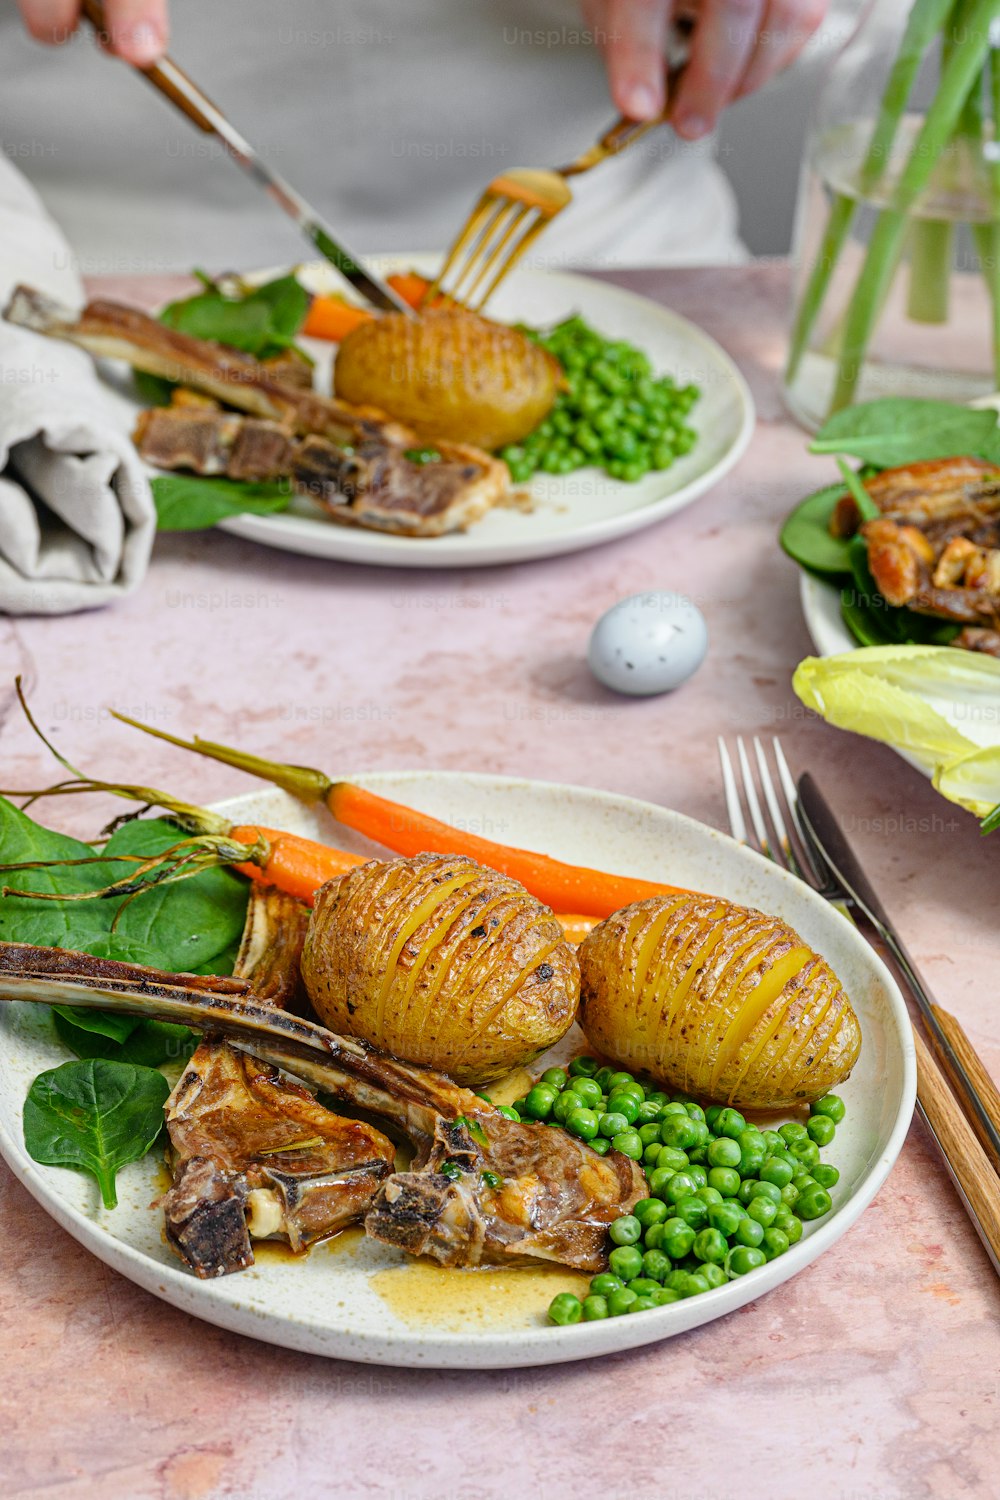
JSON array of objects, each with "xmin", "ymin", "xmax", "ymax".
[{"xmin": 333, "ymin": 308, "xmax": 562, "ymax": 450}]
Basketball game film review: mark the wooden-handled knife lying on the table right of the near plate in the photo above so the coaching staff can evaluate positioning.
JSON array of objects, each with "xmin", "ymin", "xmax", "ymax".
[{"xmin": 798, "ymin": 771, "xmax": 1000, "ymax": 1173}]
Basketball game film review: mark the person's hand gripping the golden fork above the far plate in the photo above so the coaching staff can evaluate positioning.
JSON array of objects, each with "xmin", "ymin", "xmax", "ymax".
[{"xmin": 582, "ymin": 0, "xmax": 826, "ymax": 141}]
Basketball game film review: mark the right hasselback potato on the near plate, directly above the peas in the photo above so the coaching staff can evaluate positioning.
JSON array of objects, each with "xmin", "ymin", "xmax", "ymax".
[{"xmin": 579, "ymin": 896, "xmax": 861, "ymax": 1109}]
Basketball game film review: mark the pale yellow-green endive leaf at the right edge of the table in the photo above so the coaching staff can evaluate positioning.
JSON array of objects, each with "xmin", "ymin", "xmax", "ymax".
[{"xmin": 792, "ymin": 647, "xmax": 1000, "ymax": 818}]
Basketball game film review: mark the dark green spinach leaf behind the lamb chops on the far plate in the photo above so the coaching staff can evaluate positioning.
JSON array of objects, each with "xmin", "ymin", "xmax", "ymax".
[{"xmin": 159, "ymin": 276, "xmax": 309, "ymax": 360}]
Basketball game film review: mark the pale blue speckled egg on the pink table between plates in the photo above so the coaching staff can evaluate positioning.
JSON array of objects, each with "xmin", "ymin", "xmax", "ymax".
[{"xmin": 586, "ymin": 590, "xmax": 708, "ymax": 698}]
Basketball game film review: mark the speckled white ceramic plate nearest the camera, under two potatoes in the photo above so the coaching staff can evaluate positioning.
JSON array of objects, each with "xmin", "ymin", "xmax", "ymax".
[{"xmin": 0, "ymin": 771, "xmax": 915, "ymax": 1368}]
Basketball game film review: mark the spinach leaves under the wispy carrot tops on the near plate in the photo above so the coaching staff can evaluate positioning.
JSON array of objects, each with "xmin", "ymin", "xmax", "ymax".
[{"xmin": 0, "ymin": 798, "xmax": 247, "ymax": 972}]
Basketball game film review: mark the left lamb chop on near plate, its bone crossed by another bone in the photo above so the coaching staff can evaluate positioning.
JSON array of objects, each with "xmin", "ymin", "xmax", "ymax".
[{"xmin": 162, "ymin": 887, "xmax": 396, "ymax": 1277}]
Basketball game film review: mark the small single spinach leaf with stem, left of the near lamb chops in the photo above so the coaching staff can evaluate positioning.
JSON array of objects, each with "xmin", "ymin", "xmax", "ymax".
[{"xmin": 24, "ymin": 1058, "xmax": 169, "ymax": 1209}]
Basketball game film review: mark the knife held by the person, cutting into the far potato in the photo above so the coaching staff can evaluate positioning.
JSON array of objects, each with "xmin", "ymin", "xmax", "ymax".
[{"xmin": 82, "ymin": 0, "xmax": 415, "ymax": 318}]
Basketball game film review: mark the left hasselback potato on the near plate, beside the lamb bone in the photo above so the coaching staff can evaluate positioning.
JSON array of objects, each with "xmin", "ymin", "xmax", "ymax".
[{"xmin": 301, "ymin": 854, "xmax": 580, "ymax": 1085}]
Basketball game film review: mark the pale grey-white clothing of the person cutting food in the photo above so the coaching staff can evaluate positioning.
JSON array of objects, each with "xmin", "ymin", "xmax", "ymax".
[{"xmin": 0, "ymin": 0, "xmax": 745, "ymax": 275}]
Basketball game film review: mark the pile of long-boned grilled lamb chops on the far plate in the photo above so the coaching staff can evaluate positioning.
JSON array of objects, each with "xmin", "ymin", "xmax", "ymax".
[{"xmin": 3, "ymin": 287, "xmax": 510, "ymax": 537}]
